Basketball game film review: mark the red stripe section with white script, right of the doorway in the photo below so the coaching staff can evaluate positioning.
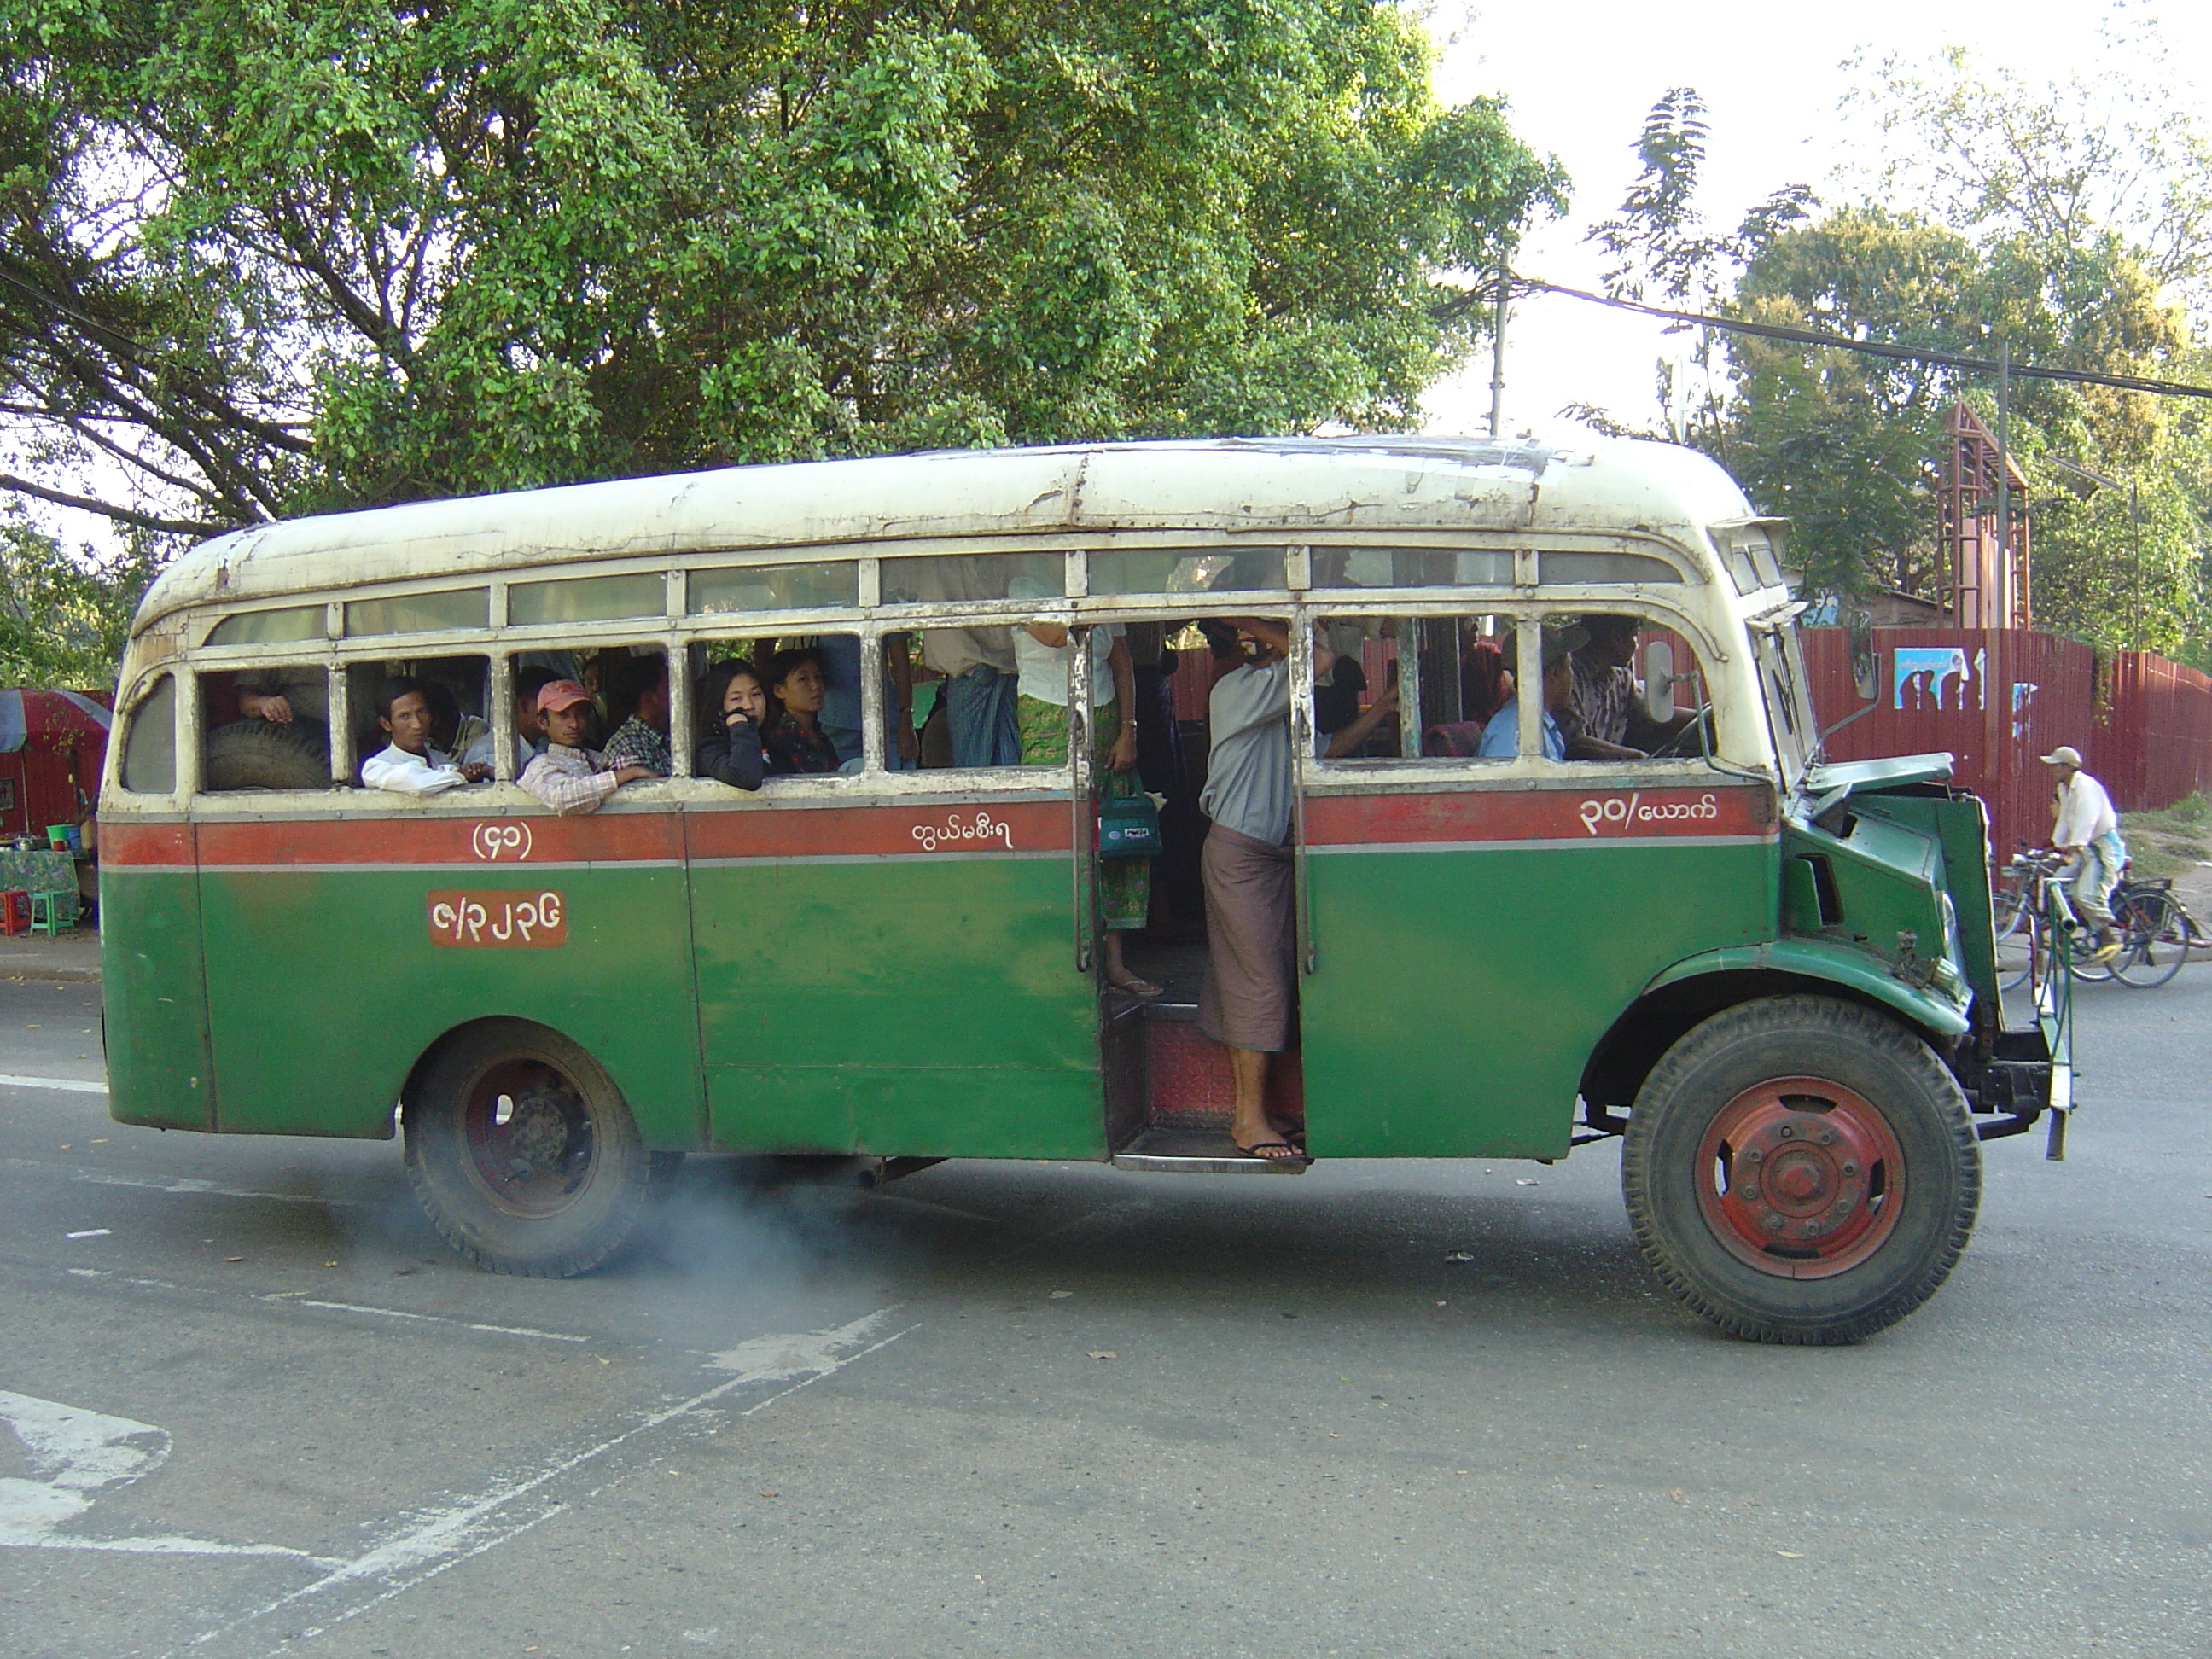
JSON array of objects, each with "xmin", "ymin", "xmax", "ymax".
[{"xmin": 1305, "ymin": 788, "xmax": 1774, "ymax": 847}]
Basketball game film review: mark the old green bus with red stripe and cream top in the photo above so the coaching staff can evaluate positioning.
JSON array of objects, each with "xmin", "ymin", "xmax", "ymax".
[{"xmin": 100, "ymin": 438, "xmax": 2070, "ymax": 1342}]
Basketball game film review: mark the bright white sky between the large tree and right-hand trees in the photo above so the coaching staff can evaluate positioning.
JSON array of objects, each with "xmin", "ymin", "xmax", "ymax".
[{"xmin": 1424, "ymin": 0, "xmax": 2212, "ymax": 440}]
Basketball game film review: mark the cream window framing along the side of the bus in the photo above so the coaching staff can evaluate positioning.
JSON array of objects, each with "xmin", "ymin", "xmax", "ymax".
[{"xmin": 155, "ymin": 527, "xmax": 1751, "ymax": 812}]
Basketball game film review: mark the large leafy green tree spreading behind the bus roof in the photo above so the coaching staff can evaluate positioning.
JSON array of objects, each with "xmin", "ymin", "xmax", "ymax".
[{"xmin": 0, "ymin": 0, "xmax": 1562, "ymax": 531}]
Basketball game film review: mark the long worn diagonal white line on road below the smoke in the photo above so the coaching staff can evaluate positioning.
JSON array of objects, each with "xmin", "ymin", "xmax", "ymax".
[{"xmin": 190, "ymin": 1307, "xmax": 920, "ymax": 1648}]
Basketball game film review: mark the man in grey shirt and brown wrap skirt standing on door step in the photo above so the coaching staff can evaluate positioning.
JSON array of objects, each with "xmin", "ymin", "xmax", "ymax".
[{"xmin": 1199, "ymin": 617, "xmax": 1336, "ymax": 1163}]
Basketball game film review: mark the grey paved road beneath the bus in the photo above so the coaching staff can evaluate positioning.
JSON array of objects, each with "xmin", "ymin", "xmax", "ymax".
[{"xmin": 0, "ymin": 967, "xmax": 2212, "ymax": 1659}]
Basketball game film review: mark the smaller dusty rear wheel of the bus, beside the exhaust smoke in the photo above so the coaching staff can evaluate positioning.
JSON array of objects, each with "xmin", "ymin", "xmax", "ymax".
[{"xmin": 403, "ymin": 1020, "xmax": 655, "ymax": 1278}]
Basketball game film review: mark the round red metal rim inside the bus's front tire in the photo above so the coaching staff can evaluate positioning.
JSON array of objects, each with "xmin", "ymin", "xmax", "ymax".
[{"xmin": 1697, "ymin": 1077, "xmax": 1905, "ymax": 1278}]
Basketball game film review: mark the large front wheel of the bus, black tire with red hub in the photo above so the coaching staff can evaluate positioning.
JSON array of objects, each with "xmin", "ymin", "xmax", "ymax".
[{"xmin": 1621, "ymin": 995, "xmax": 1982, "ymax": 1345}]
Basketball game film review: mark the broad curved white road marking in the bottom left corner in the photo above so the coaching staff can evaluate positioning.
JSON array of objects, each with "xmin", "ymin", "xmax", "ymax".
[{"xmin": 0, "ymin": 1391, "xmax": 332, "ymax": 1569}]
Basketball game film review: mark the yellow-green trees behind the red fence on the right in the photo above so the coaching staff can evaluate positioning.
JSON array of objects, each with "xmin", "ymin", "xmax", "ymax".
[{"xmin": 1592, "ymin": 55, "xmax": 2212, "ymax": 650}]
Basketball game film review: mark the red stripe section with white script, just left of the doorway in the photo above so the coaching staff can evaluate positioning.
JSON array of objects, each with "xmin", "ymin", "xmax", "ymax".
[{"xmin": 684, "ymin": 800, "xmax": 1073, "ymax": 859}]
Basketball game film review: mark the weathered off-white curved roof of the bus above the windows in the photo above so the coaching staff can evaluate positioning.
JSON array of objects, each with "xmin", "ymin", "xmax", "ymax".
[{"xmin": 135, "ymin": 436, "xmax": 1752, "ymax": 631}]
